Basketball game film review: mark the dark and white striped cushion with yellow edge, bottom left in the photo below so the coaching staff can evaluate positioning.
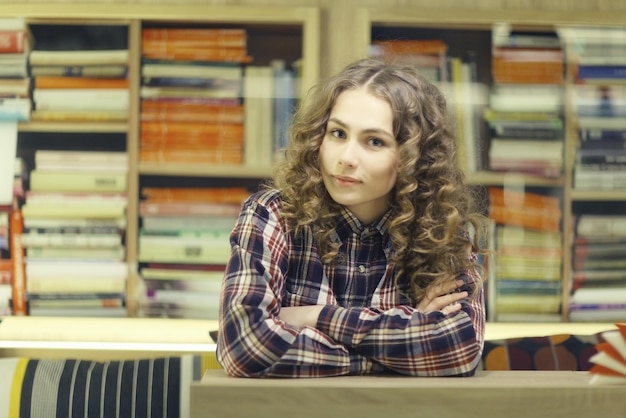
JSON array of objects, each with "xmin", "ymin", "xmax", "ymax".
[{"xmin": 0, "ymin": 355, "xmax": 217, "ymax": 418}]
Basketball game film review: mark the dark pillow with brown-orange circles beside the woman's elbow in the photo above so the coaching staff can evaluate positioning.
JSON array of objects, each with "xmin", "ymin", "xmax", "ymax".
[{"xmin": 482, "ymin": 334, "xmax": 601, "ymax": 371}]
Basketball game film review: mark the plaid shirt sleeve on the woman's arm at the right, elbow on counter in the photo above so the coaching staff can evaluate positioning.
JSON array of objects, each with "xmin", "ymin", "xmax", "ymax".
[{"xmin": 317, "ymin": 271, "xmax": 485, "ymax": 376}]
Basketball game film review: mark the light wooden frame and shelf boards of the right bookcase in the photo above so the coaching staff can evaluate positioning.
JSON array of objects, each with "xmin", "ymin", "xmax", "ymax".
[{"xmin": 353, "ymin": 8, "xmax": 626, "ymax": 321}]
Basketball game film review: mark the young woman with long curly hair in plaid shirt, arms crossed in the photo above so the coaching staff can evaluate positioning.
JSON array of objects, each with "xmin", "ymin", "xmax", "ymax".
[{"xmin": 217, "ymin": 59, "xmax": 485, "ymax": 377}]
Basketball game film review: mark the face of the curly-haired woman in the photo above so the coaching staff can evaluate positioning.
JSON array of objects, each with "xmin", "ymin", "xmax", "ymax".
[{"xmin": 320, "ymin": 87, "xmax": 398, "ymax": 224}]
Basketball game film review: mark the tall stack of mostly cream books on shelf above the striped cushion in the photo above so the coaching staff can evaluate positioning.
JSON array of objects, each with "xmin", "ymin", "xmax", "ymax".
[{"xmin": 21, "ymin": 149, "xmax": 128, "ymax": 316}]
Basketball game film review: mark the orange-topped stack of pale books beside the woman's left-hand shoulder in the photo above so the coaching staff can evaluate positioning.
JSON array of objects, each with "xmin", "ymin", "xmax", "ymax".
[{"xmin": 137, "ymin": 187, "xmax": 249, "ymax": 319}]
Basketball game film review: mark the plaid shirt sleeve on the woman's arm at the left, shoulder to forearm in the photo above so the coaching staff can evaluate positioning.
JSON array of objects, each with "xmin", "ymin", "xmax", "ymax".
[{"xmin": 217, "ymin": 201, "xmax": 382, "ymax": 377}]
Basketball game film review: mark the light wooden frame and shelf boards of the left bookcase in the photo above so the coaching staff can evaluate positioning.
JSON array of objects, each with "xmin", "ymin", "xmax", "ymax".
[{"xmin": 0, "ymin": 3, "xmax": 320, "ymax": 317}]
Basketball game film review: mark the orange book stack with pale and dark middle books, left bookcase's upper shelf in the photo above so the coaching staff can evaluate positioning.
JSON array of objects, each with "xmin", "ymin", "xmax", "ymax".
[{"xmin": 139, "ymin": 27, "xmax": 252, "ymax": 164}]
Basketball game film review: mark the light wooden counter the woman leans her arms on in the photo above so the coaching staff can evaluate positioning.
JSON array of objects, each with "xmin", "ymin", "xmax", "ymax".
[{"xmin": 191, "ymin": 370, "xmax": 626, "ymax": 418}]
